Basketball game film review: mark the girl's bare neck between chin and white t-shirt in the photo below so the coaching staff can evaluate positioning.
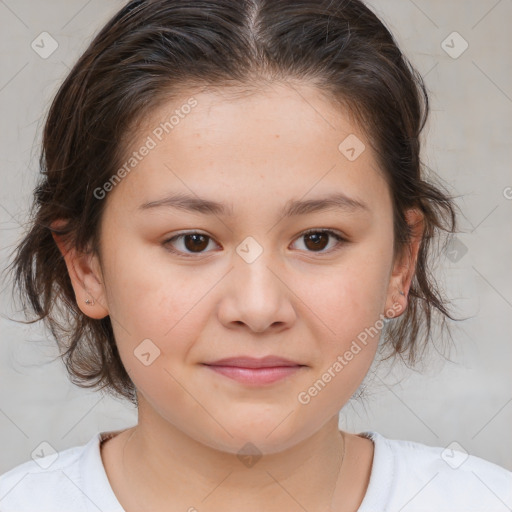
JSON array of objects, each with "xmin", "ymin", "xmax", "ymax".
[{"xmin": 122, "ymin": 404, "xmax": 350, "ymax": 512}]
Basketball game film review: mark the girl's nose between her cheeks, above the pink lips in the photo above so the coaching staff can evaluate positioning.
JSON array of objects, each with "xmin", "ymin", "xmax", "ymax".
[{"xmin": 218, "ymin": 251, "xmax": 296, "ymax": 333}]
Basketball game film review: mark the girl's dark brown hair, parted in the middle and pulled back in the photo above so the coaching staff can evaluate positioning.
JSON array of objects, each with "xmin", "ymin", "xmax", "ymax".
[{"xmin": 2, "ymin": 0, "xmax": 464, "ymax": 404}]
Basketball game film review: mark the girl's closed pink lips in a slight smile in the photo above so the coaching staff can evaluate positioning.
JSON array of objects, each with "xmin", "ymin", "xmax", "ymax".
[{"xmin": 203, "ymin": 356, "xmax": 305, "ymax": 386}]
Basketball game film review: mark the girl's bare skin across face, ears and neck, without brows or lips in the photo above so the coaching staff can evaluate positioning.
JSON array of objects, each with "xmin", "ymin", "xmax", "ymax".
[{"xmin": 55, "ymin": 84, "xmax": 422, "ymax": 512}]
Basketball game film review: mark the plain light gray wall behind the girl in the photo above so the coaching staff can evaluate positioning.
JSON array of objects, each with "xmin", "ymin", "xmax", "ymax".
[{"xmin": 0, "ymin": 0, "xmax": 512, "ymax": 474}]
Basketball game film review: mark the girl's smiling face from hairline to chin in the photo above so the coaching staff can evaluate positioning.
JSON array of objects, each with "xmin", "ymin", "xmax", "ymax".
[{"xmin": 55, "ymin": 85, "xmax": 420, "ymax": 453}]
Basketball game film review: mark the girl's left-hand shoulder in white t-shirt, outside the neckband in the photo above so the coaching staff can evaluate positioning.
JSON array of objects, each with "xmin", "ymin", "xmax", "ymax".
[{"xmin": 0, "ymin": 435, "xmax": 97, "ymax": 512}]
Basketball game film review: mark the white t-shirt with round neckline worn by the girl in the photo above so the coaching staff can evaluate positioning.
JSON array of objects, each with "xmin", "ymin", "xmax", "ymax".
[{"xmin": 0, "ymin": 431, "xmax": 512, "ymax": 512}]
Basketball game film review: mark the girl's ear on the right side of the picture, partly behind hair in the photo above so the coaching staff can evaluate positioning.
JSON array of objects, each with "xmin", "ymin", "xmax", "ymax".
[{"xmin": 385, "ymin": 208, "xmax": 424, "ymax": 318}]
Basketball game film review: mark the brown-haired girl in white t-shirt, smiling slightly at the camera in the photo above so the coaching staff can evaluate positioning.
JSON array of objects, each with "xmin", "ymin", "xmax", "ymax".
[{"xmin": 0, "ymin": 0, "xmax": 512, "ymax": 512}]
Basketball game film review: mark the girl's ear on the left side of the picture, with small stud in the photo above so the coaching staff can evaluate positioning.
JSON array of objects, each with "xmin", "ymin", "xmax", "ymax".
[{"xmin": 51, "ymin": 220, "xmax": 109, "ymax": 319}]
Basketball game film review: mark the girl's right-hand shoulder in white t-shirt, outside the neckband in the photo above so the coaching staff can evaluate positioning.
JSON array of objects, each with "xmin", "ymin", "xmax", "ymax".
[{"xmin": 360, "ymin": 432, "xmax": 512, "ymax": 512}]
